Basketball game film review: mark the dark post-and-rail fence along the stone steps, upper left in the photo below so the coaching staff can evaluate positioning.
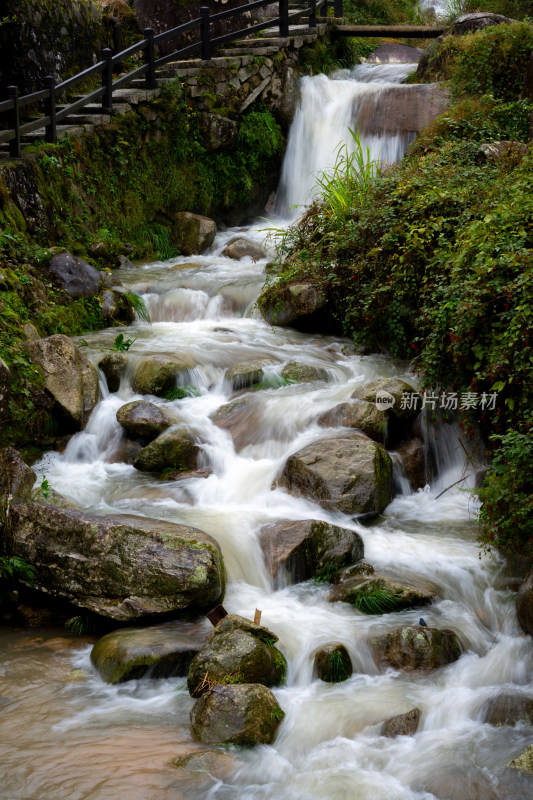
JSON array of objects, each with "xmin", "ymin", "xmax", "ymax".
[{"xmin": 0, "ymin": 0, "xmax": 342, "ymax": 158}]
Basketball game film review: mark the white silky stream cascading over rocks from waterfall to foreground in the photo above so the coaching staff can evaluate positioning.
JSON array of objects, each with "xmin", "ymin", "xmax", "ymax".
[{"xmin": 0, "ymin": 59, "xmax": 533, "ymax": 800}]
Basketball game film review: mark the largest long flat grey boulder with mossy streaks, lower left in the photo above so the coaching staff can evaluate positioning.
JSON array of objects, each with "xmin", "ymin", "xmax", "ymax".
[{"xmin": 11, "ymin": 503, "xmax": 224, "ymax": 622}]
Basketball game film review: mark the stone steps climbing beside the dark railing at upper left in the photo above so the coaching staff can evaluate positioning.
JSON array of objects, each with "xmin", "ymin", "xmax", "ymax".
[{"xmin": 0, "ymin": 3, "xmax": 328, "ymax": 156}]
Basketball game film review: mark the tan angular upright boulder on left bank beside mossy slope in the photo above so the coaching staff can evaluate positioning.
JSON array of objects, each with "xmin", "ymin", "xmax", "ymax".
[{"xmin": 25, "ymin": 334, "xmax": 99, "ymax": 430}]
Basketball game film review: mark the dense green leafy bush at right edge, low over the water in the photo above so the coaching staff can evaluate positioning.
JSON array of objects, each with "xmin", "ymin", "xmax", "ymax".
[{"xmin": 479, "ymin": 430, "xmax": 533, "ymax": 555}]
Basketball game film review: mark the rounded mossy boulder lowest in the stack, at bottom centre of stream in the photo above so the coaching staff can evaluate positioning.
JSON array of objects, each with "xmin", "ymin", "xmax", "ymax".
[{"xmin": 191, "ymin": 683, "xmax": 284, "ymax": 746}]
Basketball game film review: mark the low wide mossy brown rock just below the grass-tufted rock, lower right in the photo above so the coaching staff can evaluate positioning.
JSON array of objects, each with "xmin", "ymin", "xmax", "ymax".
[{"xmin": 372, "ymin": 625, "xmax": 461, "ymax": 672}]
